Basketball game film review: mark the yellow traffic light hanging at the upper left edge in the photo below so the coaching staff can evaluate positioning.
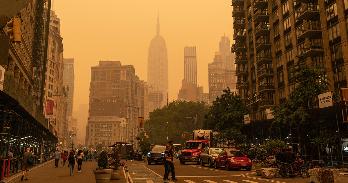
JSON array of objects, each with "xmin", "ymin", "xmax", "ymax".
[{"xmin": 5, "ymin": 17, "xmax": 22, "ymax": 43}]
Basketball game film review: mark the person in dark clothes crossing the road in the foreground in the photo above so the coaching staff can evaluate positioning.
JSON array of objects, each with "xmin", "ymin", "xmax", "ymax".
[{"xmin": 163, "ymin": 141, "xmax": 177, "ymax": 181}]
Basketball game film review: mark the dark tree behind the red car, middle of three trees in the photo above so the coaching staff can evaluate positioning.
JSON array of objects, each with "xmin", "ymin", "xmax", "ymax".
[{"xmin": 206, "ymin": 88, "xmax": 247, "ymax": 143}]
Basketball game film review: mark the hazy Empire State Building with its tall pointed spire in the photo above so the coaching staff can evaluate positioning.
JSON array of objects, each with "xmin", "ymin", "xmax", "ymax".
[{"xmin": 147, "ymin": 13, "xmax": 168, "ymax": 112}]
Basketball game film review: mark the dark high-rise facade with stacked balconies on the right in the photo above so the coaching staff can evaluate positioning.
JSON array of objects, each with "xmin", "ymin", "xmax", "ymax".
[{"xmin": 232, "ymin": 0, "xmax": 348, "ymax": 120}]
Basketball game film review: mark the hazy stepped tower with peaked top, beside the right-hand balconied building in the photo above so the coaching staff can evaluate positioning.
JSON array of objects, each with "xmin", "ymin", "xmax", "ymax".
[{"xmin": 208, "ymin": 36, "xmax": 237, "ymax": 103}]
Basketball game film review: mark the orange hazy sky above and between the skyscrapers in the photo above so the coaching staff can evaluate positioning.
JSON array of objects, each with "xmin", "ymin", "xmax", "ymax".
[{"xmin": 52, "ymin": 0, "xmax": 232, "ymax": 130}]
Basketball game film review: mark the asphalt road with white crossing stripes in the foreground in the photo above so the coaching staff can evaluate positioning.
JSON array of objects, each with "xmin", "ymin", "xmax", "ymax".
[{"xmin": 127, "ymin": 161, "xmax": 308, "ymax": 183}]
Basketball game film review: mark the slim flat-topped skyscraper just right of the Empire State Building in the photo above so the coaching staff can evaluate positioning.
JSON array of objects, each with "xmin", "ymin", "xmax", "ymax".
[{"xmin": 178, "ymin": 46, "xmax": 198, "ymax": 101}]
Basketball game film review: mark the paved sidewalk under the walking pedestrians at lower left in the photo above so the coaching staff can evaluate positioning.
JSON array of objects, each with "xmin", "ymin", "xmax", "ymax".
[{"xmin": 2, "ymin": 161, "xmax": 126, "ymax": 183}]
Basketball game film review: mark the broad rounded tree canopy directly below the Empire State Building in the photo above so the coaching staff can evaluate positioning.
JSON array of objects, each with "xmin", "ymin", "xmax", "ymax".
[{"xmin": 145, "ymin": 101, "xmax": 209, "ymax": 144}]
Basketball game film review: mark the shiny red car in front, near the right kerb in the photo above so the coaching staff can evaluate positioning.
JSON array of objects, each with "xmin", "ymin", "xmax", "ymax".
[{"xmin": 214, "ymin": 149, "xmax": 252, "ymax": 170}]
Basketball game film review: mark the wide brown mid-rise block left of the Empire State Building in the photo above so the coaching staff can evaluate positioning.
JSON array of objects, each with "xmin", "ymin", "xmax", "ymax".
[{"xmin": 86, "ymin": 61, "xmax": 148, "ymax": 146}]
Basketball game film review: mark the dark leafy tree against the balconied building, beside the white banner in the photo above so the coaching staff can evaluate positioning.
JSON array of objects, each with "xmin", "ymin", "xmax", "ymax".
[{"xmin": 271, "ymin": 68, "xmax": 335, "ymax": 154}]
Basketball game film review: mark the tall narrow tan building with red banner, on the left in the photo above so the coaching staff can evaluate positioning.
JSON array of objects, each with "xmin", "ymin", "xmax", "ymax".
[{"xmin": 44, "ymin": 11, "xmax": 68, "ymax": 142}]
